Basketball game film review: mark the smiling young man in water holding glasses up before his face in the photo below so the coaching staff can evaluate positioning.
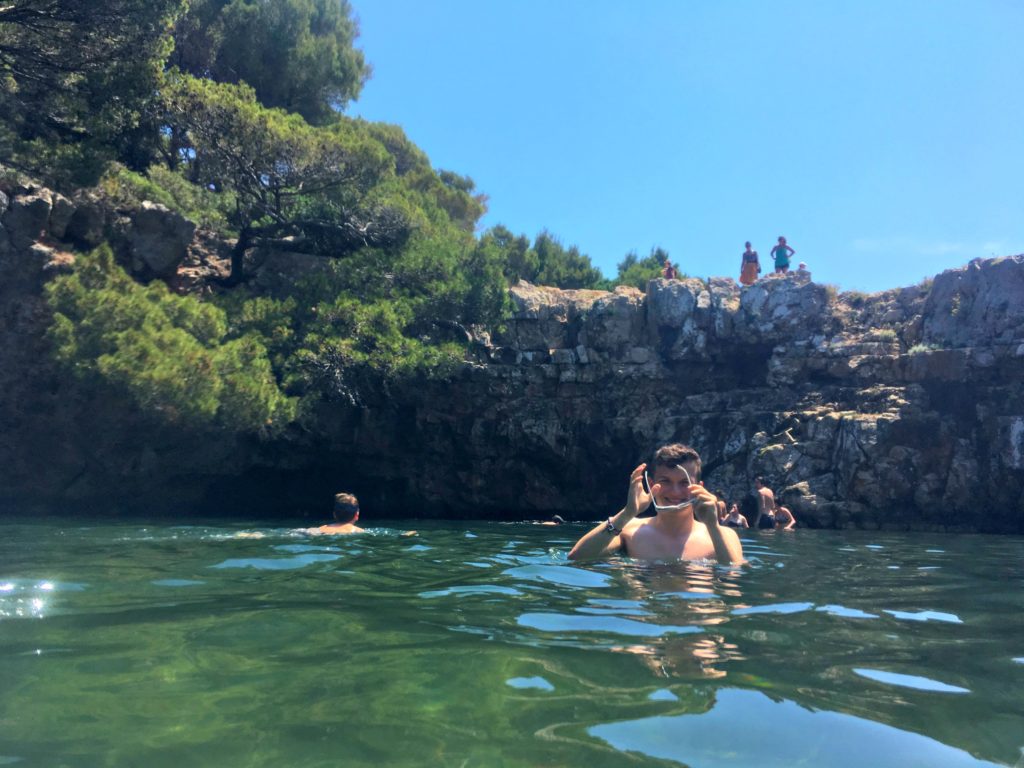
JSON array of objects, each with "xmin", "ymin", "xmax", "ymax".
[{"xmin": 569, "ymin": 442, "xmax": 743, "ymax": 564}]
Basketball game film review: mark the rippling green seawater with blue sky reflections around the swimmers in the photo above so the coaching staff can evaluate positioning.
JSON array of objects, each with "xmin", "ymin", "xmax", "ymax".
[{"xmin": 0, "ymin": 519, "xmax": 1024, "ymax": 768}]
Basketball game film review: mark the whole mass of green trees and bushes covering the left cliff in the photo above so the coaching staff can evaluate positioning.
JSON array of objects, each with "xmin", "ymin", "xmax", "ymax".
[{"xmin": 8, "ymin": 0, "xmax": 604, "ymax": 421}]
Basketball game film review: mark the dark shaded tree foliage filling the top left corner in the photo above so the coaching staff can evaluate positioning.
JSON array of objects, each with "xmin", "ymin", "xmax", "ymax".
[{"xmin": 0, "ymin": 0, "xmax": 183, "ymax": 186}]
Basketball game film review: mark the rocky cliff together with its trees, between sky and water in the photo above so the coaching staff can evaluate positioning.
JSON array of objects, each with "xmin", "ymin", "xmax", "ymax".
[{"xmin": 0, "ymin": 0, "xmax": 1024, "ymax": 530}]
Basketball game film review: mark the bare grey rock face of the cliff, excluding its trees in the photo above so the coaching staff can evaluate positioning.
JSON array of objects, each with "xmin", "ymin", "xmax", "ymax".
[{"xmin": 6, "ymin": 180, "xmax": 1024, "ymax": 532}]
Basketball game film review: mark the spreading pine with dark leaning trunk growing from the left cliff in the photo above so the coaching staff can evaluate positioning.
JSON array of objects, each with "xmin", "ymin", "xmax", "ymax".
[{"xmin": 164, "ymin": 75, "xmax": 411, "ymax": 280}]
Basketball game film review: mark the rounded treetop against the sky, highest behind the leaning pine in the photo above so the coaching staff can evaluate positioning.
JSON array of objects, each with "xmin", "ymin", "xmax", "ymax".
[{"xmin": 170, "ymin": 0, "xmax": 370, "ymax": 125}]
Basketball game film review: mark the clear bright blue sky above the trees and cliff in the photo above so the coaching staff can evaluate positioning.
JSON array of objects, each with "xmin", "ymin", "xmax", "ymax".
[{"xmin": 347, "ymin": 0, "xmax": 1024, "ymax": 291}]
